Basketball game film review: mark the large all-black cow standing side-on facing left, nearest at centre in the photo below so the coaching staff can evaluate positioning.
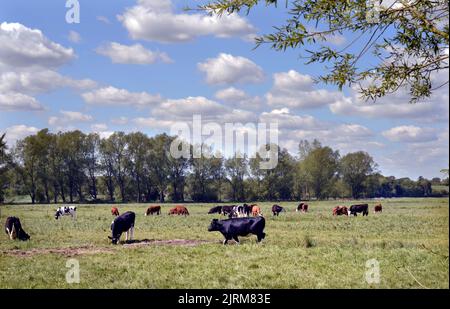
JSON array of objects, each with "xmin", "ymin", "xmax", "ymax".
[{"xmin": 208, "ymin": 217, "xmax": 266, "ymax": 245}]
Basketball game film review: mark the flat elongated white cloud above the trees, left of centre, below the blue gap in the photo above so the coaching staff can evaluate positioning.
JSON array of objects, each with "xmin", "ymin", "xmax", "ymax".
[{"xmin": 82, "ymin": 86, "xmax": 161, "ymax": 107}]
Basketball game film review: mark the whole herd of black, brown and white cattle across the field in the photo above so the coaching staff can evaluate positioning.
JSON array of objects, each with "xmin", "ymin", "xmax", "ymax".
[{"xmin": 5, "ymin": 202, "xmax": 383, "ymax": 245}]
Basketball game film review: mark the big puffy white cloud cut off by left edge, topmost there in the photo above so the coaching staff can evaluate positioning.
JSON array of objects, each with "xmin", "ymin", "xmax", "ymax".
[{"xmin": 0, "ymin": 22, "xmax": 75, "ymax": 67}]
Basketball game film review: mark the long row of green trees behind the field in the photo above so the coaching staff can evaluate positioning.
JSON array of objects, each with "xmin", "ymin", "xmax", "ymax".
[{"xmin": 0, "ymin": 129, "xmax": 448, "ymax": 204}]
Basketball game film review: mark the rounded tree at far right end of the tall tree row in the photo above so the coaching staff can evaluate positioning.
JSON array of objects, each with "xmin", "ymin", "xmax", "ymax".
[{"xmin": 340, "ymin": 151, "xmax": 376, "ymax": 198}]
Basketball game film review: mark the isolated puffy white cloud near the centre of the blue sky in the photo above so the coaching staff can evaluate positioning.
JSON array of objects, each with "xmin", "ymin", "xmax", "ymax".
[{"xmin": 197, "ymin": 53, "xmax": 264, "ymax": 85}]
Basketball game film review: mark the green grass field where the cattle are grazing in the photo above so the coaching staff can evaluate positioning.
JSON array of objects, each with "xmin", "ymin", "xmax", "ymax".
[{"xmin": 0, "ymin": 199, "xmax": 449, "ymax": 288}]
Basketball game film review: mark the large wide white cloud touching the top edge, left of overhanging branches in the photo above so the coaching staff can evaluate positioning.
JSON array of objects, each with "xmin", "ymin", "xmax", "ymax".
[{"xmin": 117, "ymin": 0, "xmax": 256, "ymax": 43}]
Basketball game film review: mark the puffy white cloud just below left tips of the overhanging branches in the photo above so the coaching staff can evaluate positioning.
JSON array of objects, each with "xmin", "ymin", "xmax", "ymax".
[{"xmin": 266, "ymin": 70, "xmax": 342, "ymax": 109}]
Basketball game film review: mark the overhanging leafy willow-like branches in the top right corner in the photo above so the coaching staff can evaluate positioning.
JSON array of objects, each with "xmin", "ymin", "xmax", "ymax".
[{"xmin": 200, "ymin": 0, "xmax": 449, "ymax": 101}]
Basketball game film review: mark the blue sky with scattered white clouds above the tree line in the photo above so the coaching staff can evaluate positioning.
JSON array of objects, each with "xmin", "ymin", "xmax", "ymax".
[{"xmin": 0, "ymin": 0, "xmax": 449, "ymax": 179}]
